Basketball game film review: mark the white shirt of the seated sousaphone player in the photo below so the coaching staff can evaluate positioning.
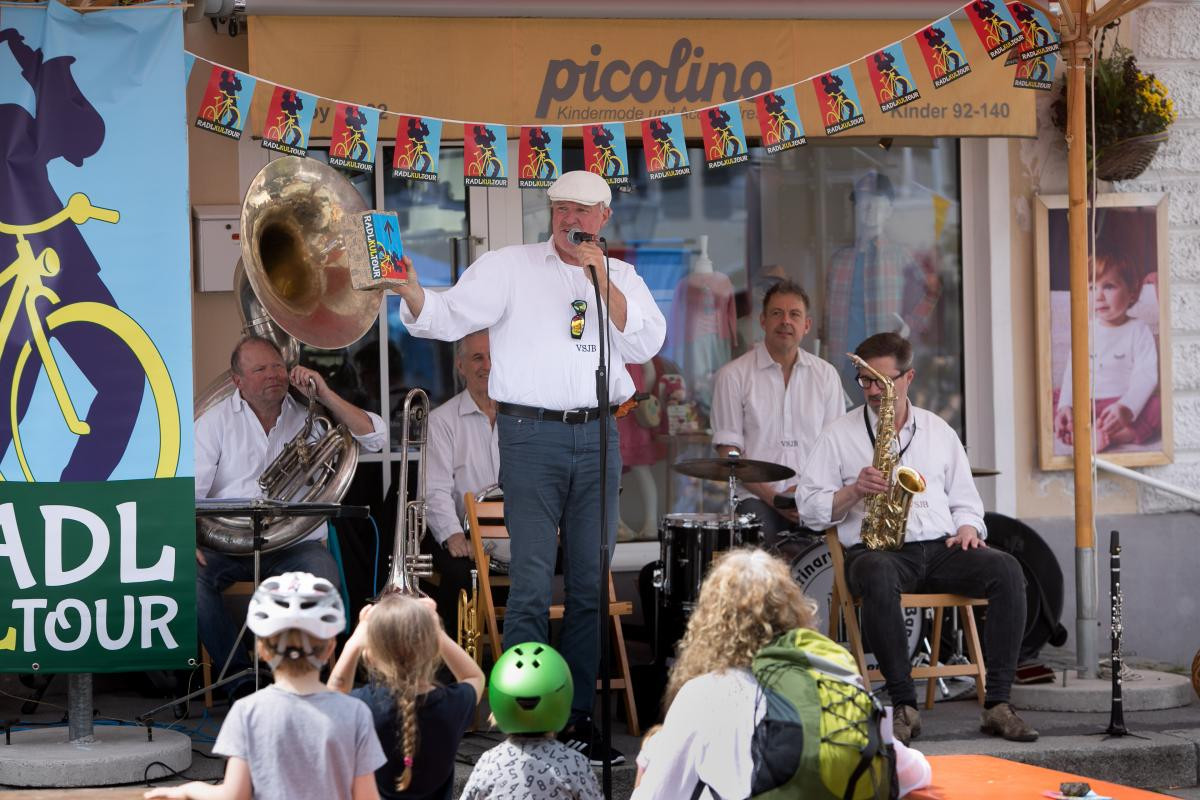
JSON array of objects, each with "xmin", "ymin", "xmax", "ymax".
[{"xmin": 193, "ymin": 390, "xmax": 388, "ymax": 541}]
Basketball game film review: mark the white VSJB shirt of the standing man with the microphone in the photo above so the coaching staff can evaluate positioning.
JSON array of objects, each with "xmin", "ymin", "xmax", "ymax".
[{"xmin": 400, "ymin": 240, "xmax": 666, "ymax": 410}]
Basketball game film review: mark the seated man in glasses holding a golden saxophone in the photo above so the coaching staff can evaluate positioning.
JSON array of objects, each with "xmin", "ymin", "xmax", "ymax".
[{"xmin": 796, "ymin": 333, "xmax": 1038, "ymax": 745}]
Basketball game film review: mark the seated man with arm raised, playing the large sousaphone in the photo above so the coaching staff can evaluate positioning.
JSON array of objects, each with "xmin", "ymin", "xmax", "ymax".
[{"xmin": 194, "ymin": 336, "xmax": 388, "ymax": 703}]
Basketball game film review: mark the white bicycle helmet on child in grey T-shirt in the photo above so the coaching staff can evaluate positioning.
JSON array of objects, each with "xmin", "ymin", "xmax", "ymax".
[{"xmin": 246, "ymin": 572, "xmax": 346, "ymax": 639}]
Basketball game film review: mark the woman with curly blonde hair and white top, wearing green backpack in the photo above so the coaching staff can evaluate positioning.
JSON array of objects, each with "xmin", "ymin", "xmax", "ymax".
[{"xmin": 632, "ymin": 549, "xmax": 930, "ymax": 800}]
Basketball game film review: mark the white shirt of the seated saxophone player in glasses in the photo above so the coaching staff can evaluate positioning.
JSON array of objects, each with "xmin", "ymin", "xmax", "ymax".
[{"xmin": 796, "ymin": 405, "xmax": 988, "ymax": 547}]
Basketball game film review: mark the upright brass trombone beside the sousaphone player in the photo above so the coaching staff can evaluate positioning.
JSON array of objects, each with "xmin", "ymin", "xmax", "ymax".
[{"xmin": 379, "ymin": 389, "xmax": 433, "ymax": 597}]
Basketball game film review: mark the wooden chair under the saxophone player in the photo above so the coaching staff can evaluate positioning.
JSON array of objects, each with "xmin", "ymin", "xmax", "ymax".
[{"xmin": 826, "ymin": 528, "xmax": 988, "ymax": 709}]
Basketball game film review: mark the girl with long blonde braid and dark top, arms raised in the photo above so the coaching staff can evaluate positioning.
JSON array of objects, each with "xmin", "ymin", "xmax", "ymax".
[{"xmin": 329, "ymin": 594, "xmax": 484, "ymax": 800}]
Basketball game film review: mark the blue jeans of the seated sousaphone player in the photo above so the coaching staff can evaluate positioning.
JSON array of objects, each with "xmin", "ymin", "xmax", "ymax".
[{"xmin": 196, "ymin": 541, "xmax": 342, "ymax": 679}]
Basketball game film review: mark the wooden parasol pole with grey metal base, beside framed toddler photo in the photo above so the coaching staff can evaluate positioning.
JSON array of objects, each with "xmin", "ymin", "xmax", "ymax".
[{"xmin": 1066, "ymin": 7, "xmax": 1099, "ymax": 678}]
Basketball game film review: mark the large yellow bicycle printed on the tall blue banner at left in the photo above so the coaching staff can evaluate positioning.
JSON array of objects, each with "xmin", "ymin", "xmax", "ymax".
[{"xmin": 0, "ymin": 192, "xmax": 180, "ymax": 481}]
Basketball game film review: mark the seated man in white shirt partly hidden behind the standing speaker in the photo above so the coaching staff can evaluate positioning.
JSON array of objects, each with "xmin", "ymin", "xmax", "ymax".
[{"xmin": 421, "ymin": 331, "xmax": 500, "ymax": 636}]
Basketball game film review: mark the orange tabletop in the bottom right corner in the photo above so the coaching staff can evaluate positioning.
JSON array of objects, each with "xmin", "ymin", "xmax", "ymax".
[{"xmin": 907, "ymin": 756, "xmax": 1166, "ymax": 800}]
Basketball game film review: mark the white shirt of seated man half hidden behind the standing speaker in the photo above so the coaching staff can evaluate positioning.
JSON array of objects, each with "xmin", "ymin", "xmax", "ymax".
[{"xmin": 425, "ymin": 390, "xmax": 500, "ymax": 545}]
